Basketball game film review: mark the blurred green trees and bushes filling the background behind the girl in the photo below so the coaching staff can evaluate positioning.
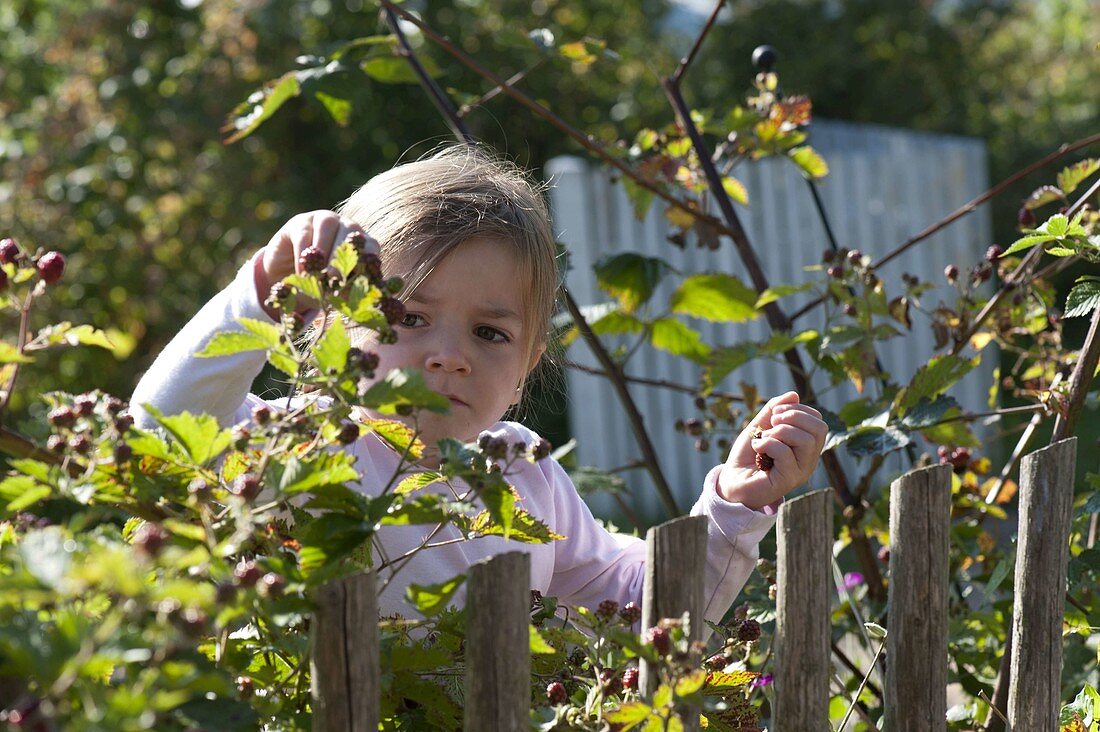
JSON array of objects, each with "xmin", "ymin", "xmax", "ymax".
[{"xmin": 0, "ymin": 0, "xmax": 1100, "ymax": 431}]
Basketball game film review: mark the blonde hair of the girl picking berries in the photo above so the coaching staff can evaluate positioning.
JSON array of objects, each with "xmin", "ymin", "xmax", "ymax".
[{"xmin": 337, "ymin": 144, "xmax": 558, "ymax": 363}]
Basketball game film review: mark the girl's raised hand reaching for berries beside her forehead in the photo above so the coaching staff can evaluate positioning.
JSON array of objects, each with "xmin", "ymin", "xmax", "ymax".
[{"xmin": 255, "ymin": 210, "xmax": 378, "ymax": 309}]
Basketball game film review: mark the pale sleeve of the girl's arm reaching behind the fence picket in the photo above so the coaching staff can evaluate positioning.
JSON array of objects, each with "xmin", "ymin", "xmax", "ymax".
[{"xmin": 545, "ymin": 453, "xmax": 778, "ymax": 635}]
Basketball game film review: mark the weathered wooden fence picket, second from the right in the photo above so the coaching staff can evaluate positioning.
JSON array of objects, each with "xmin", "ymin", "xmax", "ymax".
[{"xmin": 884, "ymin": 465, "xmax": 952, "ymax": 732}]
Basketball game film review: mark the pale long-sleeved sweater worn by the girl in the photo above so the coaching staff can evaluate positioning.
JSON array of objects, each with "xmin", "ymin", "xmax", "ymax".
[{"xmin": 131, "ymin": 256, "xmax": 777, "ymax": 622}]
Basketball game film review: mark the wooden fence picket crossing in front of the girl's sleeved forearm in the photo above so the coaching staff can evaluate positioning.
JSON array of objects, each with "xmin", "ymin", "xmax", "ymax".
[{"xmin": 638, "ymin": 516, "xmax": 706, "ymax": 730}]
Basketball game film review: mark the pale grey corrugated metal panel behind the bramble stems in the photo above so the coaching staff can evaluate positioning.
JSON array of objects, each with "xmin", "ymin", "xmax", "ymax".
[{"xmin": 547, "ymin": 121, "xmax": 996, "ymax": 516}]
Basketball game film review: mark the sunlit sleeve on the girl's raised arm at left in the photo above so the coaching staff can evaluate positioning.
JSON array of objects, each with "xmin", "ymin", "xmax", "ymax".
[{"xmin": 130, "ymin": 255, "xmax": 271, "ymax": 428}]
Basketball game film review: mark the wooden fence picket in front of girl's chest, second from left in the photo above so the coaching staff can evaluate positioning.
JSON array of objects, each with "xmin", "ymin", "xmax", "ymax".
[{"xmin": 463, "ymin": 551, "xmax": 531, "ymax": 732}]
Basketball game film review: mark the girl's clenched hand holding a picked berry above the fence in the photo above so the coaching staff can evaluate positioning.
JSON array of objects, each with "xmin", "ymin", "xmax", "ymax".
[{"xmin": 718, "ymin": 392, "xmax": 828, "ymax": 511}]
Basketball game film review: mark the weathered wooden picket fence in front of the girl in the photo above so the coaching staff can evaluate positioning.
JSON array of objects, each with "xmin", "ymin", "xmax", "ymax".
[{"xmin": 312, "ymin": 438, "xmax": 1077, "ymax": 732}]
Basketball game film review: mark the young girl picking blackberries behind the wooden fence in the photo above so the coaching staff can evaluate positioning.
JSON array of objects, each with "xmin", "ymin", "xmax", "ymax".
[{"xmin": 131, "ymin": 146, "xmax": 826, "ymax": 622}]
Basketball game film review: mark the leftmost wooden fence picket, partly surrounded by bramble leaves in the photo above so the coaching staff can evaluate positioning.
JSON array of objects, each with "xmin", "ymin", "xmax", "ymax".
[{"xmin": 309, "ymin": 572, "xmax": 382, "ymax": 732}]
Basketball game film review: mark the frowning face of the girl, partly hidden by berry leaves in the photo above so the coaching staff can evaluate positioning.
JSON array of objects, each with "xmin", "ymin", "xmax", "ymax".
[{"xmin": 367, "ymin": 237, "xmax": 545, "ymax": 448}]
